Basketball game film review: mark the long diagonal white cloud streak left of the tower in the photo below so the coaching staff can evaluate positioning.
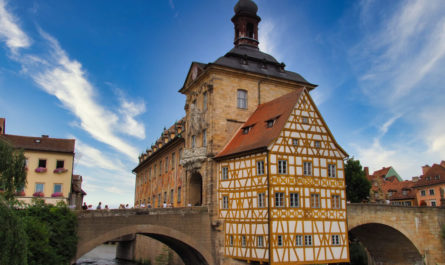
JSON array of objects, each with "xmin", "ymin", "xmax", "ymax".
[{"xmin": 31, "ymin": 31, "xmax": 138, "ymax": 160}]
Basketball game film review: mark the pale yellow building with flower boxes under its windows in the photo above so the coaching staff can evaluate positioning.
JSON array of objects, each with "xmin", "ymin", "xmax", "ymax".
[{"xmin": 0, "ymin": 119, "xmax": 75, "ymax": 204}]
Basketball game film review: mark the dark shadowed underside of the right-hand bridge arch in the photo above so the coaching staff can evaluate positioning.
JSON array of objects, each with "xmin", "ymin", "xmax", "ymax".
[{"xmin": 349, "ymin": 223, "xmax": 424, "ymax": 265}]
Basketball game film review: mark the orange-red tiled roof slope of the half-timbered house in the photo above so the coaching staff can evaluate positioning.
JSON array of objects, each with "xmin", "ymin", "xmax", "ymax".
[{"xmin": 215, "ymin": 88, "xmax": 304, "ymax": 160}]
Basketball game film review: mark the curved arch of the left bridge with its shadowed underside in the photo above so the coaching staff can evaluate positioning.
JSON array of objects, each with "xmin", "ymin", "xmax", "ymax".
[{"xmin": 76, "ymin": 224, "xmax": 214, "ymax": 265}]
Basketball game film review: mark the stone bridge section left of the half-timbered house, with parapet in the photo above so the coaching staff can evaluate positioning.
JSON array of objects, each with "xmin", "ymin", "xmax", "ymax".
[{"xmin": 76, "ymin": 207, "xmax": 216, "ymax": 265}]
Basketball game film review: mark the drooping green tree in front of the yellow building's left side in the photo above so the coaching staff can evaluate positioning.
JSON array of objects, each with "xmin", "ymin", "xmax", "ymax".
[{"xmin": 0, "ymin": 138, "xmax": 26, "ymax": 200}]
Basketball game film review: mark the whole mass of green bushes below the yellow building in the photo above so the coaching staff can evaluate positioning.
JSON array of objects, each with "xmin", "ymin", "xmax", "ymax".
[{"xmin": 0, "ymin": 199, "xmax": 77, "ymax": 265}]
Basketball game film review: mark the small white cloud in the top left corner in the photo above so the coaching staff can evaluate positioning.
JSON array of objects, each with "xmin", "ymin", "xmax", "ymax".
[{"xmin": 0, "ymin": 0, "xmax": 31, "ymax": 51}]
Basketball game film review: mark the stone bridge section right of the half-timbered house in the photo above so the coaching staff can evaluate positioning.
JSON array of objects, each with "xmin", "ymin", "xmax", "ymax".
[{"xmin": 348, "ymin": 204, "xmax": 445, "ymax": 265}]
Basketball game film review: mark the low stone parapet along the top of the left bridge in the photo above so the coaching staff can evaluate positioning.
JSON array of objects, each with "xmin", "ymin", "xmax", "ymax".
[{"xmin": 75, "ymin": 206, "xmax": 208, "ymax": 218}]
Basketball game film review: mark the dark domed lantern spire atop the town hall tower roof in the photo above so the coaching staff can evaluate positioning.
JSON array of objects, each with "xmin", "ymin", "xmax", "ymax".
[{"xmin": 232, "ymin": 0, "xmax": 261, "ymax": 49}]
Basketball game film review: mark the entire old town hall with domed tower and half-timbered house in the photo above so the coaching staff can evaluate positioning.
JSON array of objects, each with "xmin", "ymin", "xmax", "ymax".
[{"xmin": 134, "ymin": 0, "xmax": 349, "ymax": 264}]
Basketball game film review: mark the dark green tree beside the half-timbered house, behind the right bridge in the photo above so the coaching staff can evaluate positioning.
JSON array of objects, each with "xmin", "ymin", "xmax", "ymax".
[{"xmin": 345, "ymin": 158, "xmax": 371, "ymax": 202}]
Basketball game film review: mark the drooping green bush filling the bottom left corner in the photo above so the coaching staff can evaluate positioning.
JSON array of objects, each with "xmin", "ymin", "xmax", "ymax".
[{"xmin": 0, "ymin": 196, "xmax": 28, "ymax": 265}]
